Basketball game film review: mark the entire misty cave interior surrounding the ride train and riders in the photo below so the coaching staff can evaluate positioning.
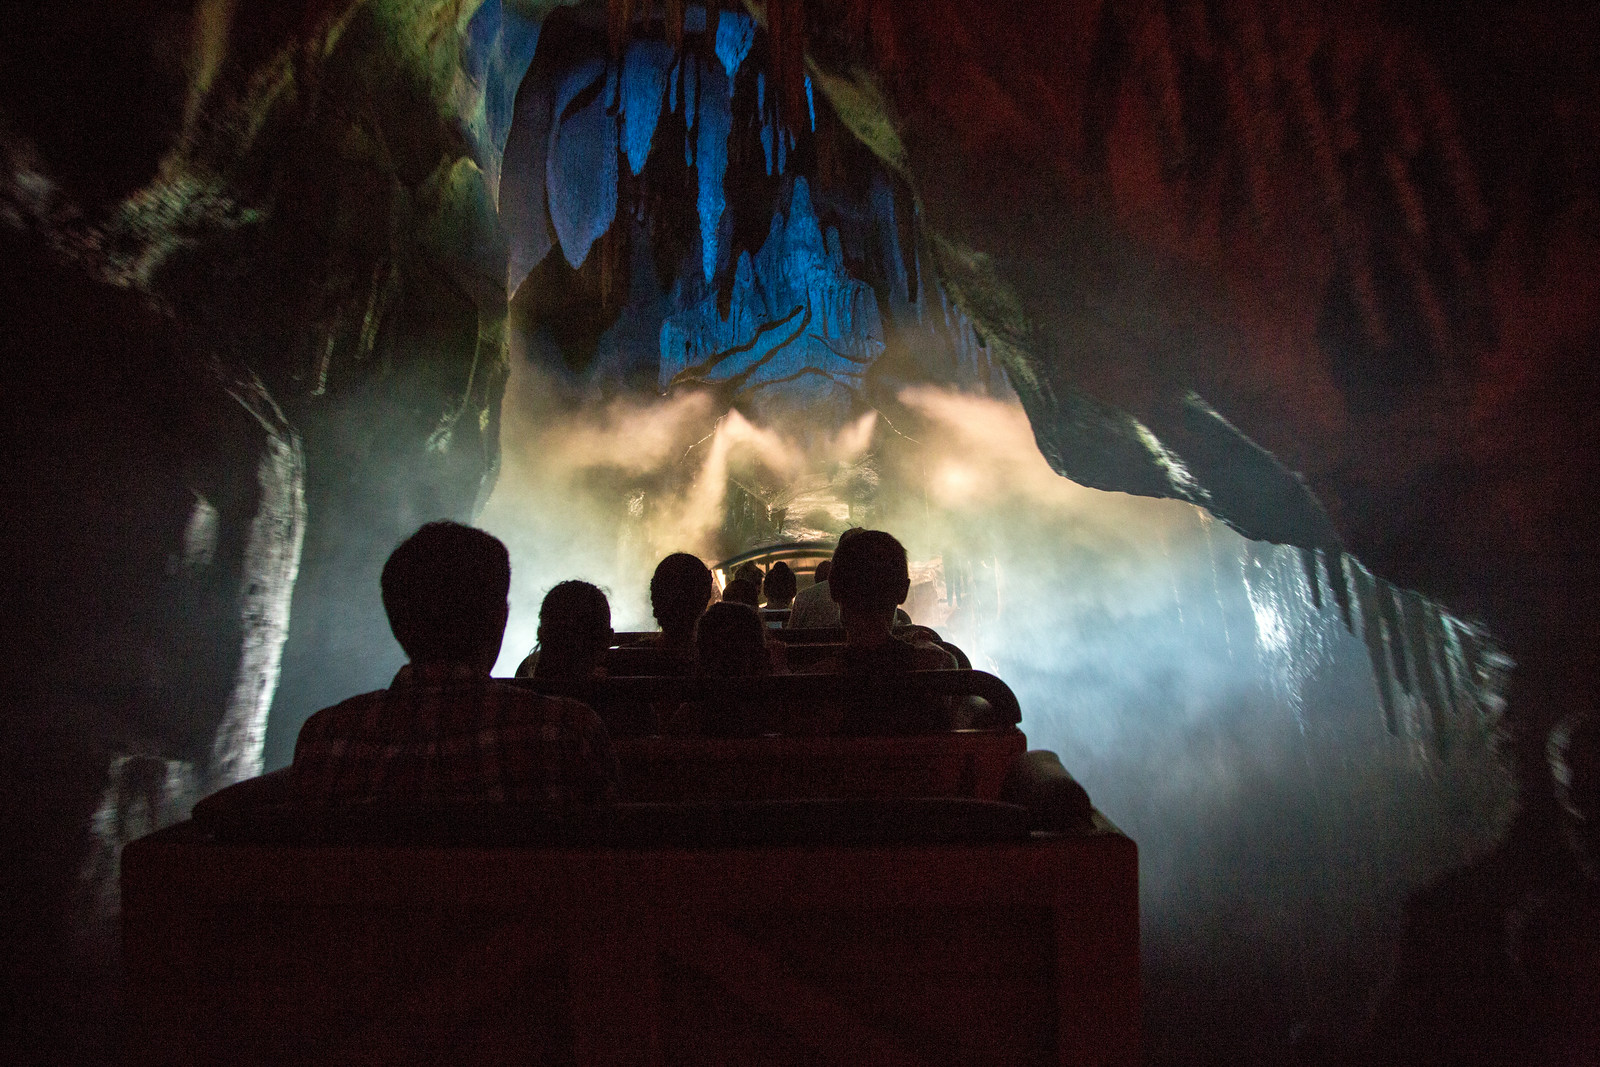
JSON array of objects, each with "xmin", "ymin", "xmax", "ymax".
[{"xmin": 0, "ymin": 0, "xmax": 1600, "ymax": 1064}]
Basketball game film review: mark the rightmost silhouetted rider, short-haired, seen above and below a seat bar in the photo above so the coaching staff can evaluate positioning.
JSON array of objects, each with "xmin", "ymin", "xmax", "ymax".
[{"xmin": 810, "ymin": 530, "xmax": 957, "ymax": 734}]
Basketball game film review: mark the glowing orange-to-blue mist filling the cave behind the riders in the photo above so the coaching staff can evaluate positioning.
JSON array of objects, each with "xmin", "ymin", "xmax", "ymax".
[{"xmin": 480, "ymin": 351, "xmax": 1512, "ymax": 1057}]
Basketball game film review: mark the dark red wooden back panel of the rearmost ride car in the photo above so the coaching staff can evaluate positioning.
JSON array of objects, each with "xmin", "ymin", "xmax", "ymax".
[{"xmin": 131, "ymin": 801, "xmax": 1139, "ymax": 1067}]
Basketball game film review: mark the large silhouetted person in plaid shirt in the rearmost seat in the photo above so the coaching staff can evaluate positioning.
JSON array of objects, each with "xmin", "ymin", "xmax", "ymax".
[{"xmin": 290, "ymin": 522, "xmax": 616, "ymax": 809}]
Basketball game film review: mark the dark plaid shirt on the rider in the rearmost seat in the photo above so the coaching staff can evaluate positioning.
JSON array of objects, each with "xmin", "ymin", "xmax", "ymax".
[{"xmin": 293, "ymin": 664, "xmax": 616, "ymax": 811}]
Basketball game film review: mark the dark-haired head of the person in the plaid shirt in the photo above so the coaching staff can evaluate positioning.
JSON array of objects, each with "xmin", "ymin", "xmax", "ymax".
[{"xmin": 381, "ymin": 522, "xmax": 510, "ymax": 661}]
